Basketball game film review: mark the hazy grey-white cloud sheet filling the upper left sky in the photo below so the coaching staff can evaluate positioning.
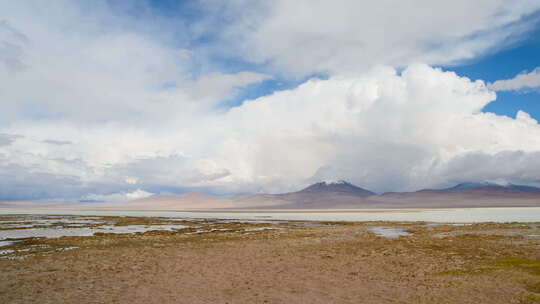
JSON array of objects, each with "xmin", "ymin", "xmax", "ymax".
[{"xmin": 0, "ymin": 1, "xmax": 270, "ymax": 125}]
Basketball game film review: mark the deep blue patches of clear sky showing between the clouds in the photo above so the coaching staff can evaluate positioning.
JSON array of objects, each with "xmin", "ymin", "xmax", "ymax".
[{"xmin": 149, "ymin": 0, "xmax": 540, "ymax": 119}]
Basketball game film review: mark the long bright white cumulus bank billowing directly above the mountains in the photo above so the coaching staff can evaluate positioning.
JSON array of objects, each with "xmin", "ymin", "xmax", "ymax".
[{"xmin": 1, "ymin": 65, "xmax": 540, "ymax": 197}]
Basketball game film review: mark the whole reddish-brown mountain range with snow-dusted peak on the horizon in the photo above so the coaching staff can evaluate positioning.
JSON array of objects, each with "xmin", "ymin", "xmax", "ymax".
[{"xmin": 93, "ymin": 181, "xmax": 540, "ymax": 210}]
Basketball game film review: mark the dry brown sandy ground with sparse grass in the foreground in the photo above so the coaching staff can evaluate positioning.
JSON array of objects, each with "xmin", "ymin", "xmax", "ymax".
[{"xmin": 0, "ymin": 219, "xmax": 540, "ymax": 304}]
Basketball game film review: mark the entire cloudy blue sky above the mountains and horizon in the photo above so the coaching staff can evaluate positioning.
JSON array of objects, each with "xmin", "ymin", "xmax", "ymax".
[{"xmin": 0, "ymin": 0, "xmax": 540, "ymax": 201}]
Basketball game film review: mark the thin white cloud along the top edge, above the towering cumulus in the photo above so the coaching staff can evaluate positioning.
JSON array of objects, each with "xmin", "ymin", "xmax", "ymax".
[{"xmin": 201, "ymin": 0, "xmax": 540, "ymax": 75}]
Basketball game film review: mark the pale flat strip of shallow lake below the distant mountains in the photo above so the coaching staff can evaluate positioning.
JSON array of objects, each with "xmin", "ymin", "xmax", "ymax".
[{"xmin": 0, "ymin": 207, "xmax": 540, "ymax": 223}]
